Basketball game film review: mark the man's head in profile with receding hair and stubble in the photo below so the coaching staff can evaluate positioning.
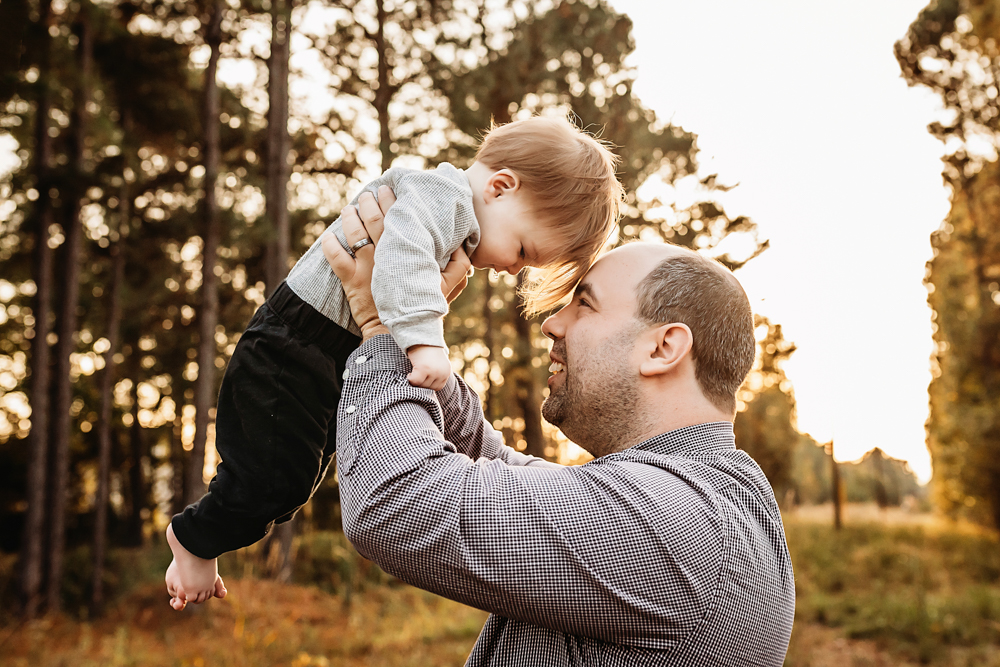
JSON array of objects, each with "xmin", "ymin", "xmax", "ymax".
[{"xmin": 542, "ymin": 243, "xmax": 755, "ymax": 456}]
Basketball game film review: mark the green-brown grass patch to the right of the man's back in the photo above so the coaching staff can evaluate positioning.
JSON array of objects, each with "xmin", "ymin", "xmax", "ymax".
[{"xmin": 785, "ymin": 521, "xmax": 1000, "ymax": 664}]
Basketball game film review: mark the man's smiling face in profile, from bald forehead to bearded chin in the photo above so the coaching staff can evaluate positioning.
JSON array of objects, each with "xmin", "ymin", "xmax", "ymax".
[{"xmin": 542, "ymin": 245, "xmax": 663, "ymax": 456}]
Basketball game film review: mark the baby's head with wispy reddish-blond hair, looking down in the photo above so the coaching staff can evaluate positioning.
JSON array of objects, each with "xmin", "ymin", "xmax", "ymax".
[{"xmin": 467, "ymin": 116, "xmax": 624, "ymax": 313}]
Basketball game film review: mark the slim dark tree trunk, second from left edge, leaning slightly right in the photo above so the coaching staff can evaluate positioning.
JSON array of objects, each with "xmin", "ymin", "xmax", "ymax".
[{"xmin": 46, "ymin": 3, "xmax": 93, "ymax": 611}]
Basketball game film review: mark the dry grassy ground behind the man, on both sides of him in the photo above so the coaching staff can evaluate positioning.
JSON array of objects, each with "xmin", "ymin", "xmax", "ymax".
[{"xmin": 0, "ymin": 508, "xmax": 1000, "ymax": 667}]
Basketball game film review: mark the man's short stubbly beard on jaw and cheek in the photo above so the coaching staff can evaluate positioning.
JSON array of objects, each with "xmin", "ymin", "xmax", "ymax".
[{"xmin": 542, "ymin": 327, "xmax": 645, "ymax": 456}]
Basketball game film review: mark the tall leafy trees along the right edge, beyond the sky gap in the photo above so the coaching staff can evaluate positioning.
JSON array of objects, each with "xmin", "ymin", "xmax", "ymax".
[{"xmin": 896, "ymin": 0, "xmax": 1000, "ymax": 526}]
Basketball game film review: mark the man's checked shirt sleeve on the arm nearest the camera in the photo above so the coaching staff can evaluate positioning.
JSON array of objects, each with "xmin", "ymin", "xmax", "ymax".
[{"xmin": 337, "ymin": 336, "xmax": 721, "ymax": 647}]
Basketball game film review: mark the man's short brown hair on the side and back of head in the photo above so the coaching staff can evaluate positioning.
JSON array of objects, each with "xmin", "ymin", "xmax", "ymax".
[{"xmin": 636, "ymin": 252, "xmax": 757, "ymax": 414}]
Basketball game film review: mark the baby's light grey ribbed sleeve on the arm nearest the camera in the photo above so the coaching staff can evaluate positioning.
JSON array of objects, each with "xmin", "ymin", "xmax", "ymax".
[{"xmin": 372, "ymin": 171, "xmax": 468, "ymax": 350}]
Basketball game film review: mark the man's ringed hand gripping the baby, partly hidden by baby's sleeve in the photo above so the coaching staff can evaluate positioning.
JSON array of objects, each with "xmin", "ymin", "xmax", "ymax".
[{"xmin": 322, "ymin": 185, "xmax": 472, "ymax": 342}]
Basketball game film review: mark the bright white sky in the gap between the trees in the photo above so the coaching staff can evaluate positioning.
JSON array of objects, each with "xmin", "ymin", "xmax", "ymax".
[{"xmin": 612, "ymin": 0, "xmax": 948, "ymax": 480}]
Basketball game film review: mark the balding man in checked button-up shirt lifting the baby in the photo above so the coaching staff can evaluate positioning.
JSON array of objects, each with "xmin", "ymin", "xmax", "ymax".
[{"xmin": 326, "ymin": 192, "xmax": 795, "ymax": 667}]
